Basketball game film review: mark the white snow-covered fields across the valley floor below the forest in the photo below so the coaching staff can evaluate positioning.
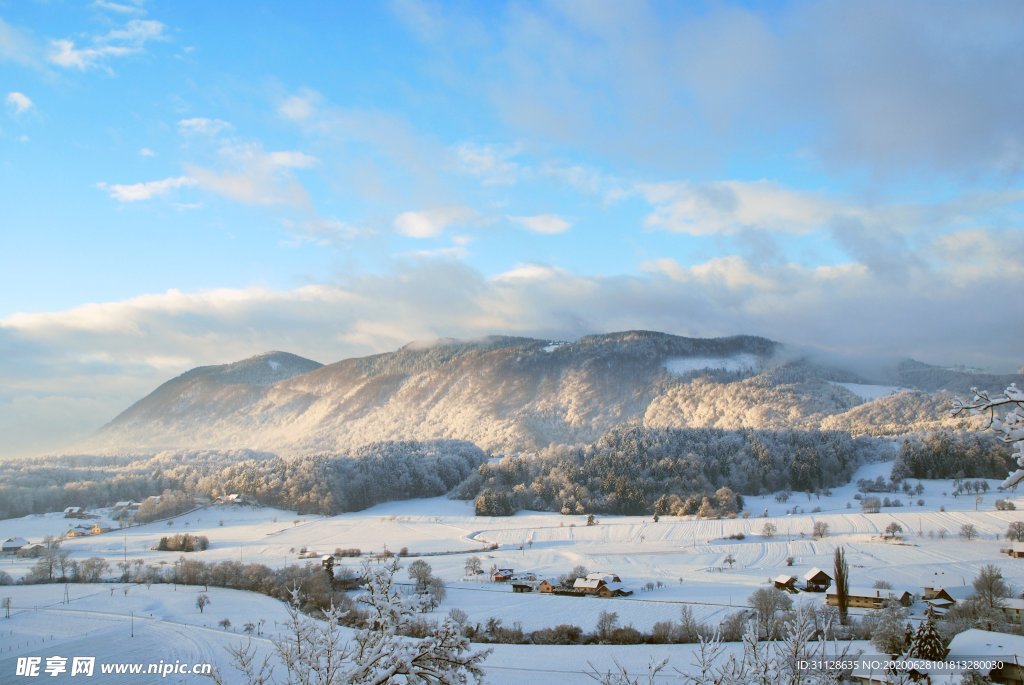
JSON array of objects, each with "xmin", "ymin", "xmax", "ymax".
[{"xmin": 0, "ymin": 463, "xmax": 1024, "ymax": 683}]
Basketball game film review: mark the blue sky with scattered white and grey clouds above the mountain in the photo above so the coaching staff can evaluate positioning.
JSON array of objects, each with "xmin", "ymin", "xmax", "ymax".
[{"xmin": 0, "ymin": 0, "xmax": 1024, "ymax": 454}]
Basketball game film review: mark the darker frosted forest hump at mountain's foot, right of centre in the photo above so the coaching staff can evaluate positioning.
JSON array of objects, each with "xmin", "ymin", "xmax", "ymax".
[{"xmin": 453, "ymin": 426, "xmax": 890, "ymax": 515}]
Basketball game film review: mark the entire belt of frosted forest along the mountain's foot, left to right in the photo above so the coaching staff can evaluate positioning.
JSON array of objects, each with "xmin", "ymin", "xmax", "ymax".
[{"xmin": 0, "ymin": 426, "xmax": 1013, "ymax": 522}]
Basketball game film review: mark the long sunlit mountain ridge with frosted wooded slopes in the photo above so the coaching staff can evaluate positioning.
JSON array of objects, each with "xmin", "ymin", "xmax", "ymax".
[{"xmin": 79, "ymin": 331, "xmax": 1020, "ymax": 455}]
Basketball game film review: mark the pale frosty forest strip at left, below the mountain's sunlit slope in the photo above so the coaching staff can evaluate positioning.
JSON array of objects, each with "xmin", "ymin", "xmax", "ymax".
[{"xmin": 0, "ymin": 440, "xmax": 486, "ymax": 518}]
